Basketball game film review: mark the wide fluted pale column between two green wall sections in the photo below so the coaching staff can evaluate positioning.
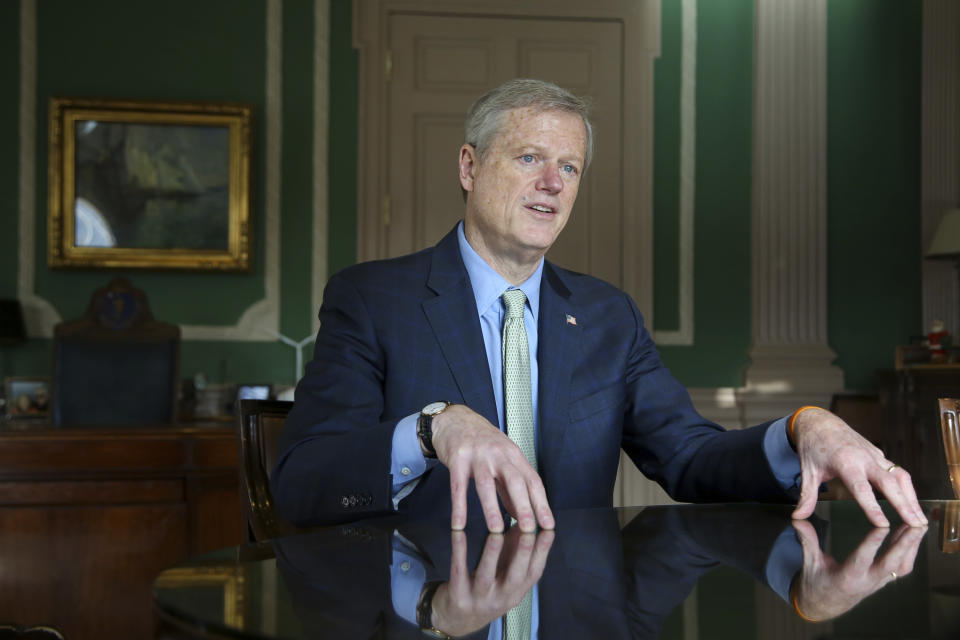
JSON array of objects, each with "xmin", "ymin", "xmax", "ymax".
[{"xmin": 740, "ymin": 0, "xmax": 843, "ymax": 424}]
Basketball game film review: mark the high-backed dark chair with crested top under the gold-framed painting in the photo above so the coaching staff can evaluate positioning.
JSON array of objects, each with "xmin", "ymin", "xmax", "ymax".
[{"xmin": 52, "ymin": 278, "xmax": 180, "ymax": 426}]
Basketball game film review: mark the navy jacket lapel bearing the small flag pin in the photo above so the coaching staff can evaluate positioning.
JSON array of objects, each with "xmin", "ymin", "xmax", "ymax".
[{"xmin": 537, "ymin": 262, "xmax": 580, "ymax": 480}]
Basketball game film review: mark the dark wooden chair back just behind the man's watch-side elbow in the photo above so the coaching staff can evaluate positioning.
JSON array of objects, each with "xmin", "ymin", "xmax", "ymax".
[{"xmin": 239, "ymin": 400, "xmax": 298, "ymax": 542}]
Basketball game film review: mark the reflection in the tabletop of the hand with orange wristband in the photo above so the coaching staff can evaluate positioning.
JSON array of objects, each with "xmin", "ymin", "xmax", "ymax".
[{"xmin": 791, "ymin": 520, "xmax": 926, "ymax": 622}]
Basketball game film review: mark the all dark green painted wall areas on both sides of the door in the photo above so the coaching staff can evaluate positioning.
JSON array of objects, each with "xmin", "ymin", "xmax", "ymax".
[{"xmin": 0, "ymin": 0, "xmax": 922, "ymax": 388}]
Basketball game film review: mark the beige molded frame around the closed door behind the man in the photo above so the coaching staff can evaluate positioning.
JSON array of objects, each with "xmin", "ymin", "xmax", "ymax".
[{"xmin": 353, "ymin": 0, "xmax": 660, "ymax": 318}]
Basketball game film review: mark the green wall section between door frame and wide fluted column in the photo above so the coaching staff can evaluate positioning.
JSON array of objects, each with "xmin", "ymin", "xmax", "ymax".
[{"xmin": 654, "ymin": 0, "xmax": 753, "ymax": 387}]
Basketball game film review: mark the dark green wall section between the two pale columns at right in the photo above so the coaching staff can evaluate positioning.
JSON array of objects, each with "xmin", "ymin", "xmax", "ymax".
[{"xmin": 827, "ymin": 0, "xmax": 924, "ymax": 389}]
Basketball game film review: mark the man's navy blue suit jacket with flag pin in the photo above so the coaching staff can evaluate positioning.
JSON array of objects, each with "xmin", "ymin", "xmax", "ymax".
[{"xmin": 271, "ymin": 225, "xmax": 791, "ymax": 526}]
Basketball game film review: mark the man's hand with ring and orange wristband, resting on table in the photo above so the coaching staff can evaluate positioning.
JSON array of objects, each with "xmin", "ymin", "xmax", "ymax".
[{"xmin": 793, "ymin": 409, "xmax": 927, "ymax": 527}]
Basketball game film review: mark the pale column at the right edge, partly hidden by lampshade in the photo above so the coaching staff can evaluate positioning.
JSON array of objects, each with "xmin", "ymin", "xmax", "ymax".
[{"xmin": 917, "ymin": 0, "xmax": 960, "ymax": 342}]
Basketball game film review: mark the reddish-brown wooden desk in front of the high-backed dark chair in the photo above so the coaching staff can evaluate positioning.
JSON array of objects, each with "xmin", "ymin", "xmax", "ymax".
[{"xmin": 0, "ymin": 425, "xmax": 244, "ymax": 640}]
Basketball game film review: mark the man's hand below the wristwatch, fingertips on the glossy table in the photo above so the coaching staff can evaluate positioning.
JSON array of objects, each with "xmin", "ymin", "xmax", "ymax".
[{"xmin": 432, "ymin": 404, "xmax": 554, "ymax": 532}]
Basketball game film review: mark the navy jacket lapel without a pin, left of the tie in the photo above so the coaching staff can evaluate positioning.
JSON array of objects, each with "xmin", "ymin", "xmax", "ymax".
[{"xmin": 423, "ymin": 229, "xmax": 499, "ymax": 425}]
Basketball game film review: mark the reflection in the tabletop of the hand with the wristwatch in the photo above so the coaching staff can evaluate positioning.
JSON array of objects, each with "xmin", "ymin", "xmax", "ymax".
[{"xmin": 432, "ymin": 527, "xmax": 553, "ymax": 636}]
